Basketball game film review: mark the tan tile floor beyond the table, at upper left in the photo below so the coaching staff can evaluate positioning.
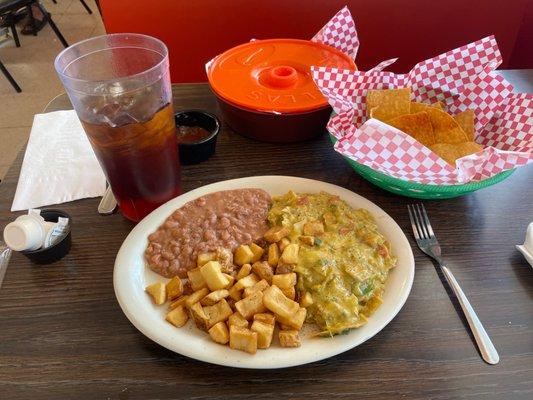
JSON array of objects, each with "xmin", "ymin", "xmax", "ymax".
[{"xmin": 0, "ymin": 0, "xmax": 105, "ymax": 179}]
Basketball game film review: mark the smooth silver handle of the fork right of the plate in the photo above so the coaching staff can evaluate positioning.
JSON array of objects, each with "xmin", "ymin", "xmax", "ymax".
[{"xmin": 441, "ymin": 265, "xmax": 500, "ymax": 364}]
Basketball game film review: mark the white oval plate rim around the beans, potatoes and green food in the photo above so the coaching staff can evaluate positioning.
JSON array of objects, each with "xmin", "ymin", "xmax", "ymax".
[{"xmin": 113, "ymin": 176, "xmax": 415, "ymax": 369}]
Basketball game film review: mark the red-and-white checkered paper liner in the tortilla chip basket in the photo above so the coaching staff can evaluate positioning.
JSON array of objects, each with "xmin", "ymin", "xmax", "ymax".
[{"xmin": 312, "ymin": 26, "xmax": 533, "ymax": 185}]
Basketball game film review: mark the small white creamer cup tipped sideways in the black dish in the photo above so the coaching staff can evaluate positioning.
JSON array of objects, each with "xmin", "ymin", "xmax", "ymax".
[{"xmin": 4, "ymin": 215, "xmax": 46, "ymax": 251}]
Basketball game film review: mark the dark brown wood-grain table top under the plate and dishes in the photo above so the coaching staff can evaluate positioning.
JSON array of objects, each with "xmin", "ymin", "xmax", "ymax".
[{"xmin": 0, "ymin": 70, "xmax": 533, "ymax": 400}]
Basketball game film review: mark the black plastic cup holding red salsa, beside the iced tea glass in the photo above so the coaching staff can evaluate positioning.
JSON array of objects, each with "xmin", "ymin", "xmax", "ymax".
[{"xmin": 174, "ymin": 110, "xmax": 220, "ymax": 165}]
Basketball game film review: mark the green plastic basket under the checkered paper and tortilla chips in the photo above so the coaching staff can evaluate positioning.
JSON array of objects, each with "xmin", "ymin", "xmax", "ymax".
[{"xmin": 330, "ymin": 134, "xmax": 514, "ymax": 200}]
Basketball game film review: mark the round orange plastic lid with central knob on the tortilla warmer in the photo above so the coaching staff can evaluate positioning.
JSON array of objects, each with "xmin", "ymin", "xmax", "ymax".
[{"xmin": 207, "ymin": 39, "xmax": 357, "ymax": 113}]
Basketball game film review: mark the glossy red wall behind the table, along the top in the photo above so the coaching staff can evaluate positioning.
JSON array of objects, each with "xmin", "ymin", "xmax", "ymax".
[{"xmin": 100, "ymin": 0, "xmax": 533, "ymax": 82}]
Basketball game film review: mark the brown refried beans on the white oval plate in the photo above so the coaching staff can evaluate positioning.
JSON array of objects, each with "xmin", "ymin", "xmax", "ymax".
[{"xmin": 145, "ymin": 189, "xmax": 270, "ymax": 278}]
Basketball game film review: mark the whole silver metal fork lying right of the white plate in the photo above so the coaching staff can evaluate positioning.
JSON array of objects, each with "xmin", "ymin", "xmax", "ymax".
[{"xmin": 407, "ymin": 204, "xmax": 500, "ymax": 364}]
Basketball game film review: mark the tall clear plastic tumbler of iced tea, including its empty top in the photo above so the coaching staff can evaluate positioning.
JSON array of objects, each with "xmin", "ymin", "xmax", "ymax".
[{"xmin": 55, "ymin": 33, "xmax": 181, "ymax": 221}]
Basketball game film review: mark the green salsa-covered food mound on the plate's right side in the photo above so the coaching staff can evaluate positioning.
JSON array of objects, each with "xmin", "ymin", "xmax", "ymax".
[{"xmin": 268, "ymin": 191, "xmax": 396, "ymax": 335}]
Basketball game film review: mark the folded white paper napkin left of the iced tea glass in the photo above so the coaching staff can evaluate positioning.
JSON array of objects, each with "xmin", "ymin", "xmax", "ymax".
[{"xmin": 11, "ymin": 110, "xmax": 106, "ymax": 211}]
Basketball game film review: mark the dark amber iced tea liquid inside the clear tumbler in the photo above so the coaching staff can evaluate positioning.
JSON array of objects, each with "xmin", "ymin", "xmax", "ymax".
[{"xmin": 82, "ymin": 104, "xmax": 181, "ymax": 221}]
